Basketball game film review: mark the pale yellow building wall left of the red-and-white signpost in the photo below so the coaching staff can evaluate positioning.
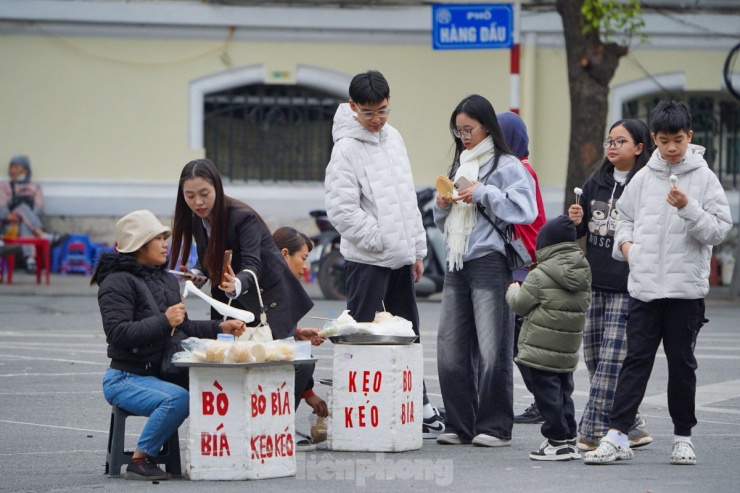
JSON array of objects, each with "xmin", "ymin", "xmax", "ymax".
[{"xmin": 0, "ymin": 32, "xmax": 509, "ymax": 183}]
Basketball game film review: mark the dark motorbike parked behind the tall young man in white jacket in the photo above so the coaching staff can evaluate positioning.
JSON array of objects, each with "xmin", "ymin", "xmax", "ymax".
[{"xmin": 307, "ymin": 188, "xmax": 445, "ymax": 300}]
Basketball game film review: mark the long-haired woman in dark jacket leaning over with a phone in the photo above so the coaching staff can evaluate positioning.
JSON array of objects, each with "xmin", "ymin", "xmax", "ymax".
[{"xmin": 170, "ymin": 159, "xmax": 327, "ymax": 424}]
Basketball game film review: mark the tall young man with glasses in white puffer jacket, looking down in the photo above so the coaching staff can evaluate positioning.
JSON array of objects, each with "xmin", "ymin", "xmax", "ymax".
[{"xmin": 324, "ymin": 70, "xmax": 444, "ymax": 438}]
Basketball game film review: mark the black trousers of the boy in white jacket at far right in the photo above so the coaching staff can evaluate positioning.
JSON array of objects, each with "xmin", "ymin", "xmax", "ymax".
[{"xmin": 610, "ymin": 298, "xmax": 708, "ymax": 436}]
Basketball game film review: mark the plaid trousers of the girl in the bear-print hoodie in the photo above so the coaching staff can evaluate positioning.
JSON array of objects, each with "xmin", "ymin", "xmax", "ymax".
[{"xmin": 579, "ymin": 289, "xmax": 629, "ymax": 439}]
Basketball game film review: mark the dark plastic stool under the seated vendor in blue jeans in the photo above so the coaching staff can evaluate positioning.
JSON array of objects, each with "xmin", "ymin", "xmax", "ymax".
[{"xmin": 105, "ymin": 406, "xmax": 182, "ymax": 478}]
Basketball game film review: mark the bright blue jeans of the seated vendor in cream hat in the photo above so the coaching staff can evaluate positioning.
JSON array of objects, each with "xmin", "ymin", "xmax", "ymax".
[{"xmin": 103, "ymin": 368, "xmax": 190, "ymax": 456}]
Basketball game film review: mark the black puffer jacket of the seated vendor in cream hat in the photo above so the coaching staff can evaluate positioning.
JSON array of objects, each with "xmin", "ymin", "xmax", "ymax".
[{"xmin": 93, "ymin": 253, "xmax": 221, "ymax": 376}]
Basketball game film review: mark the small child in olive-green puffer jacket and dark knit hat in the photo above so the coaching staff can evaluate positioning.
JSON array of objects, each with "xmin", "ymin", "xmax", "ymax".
[{"xmin": 506, "ymin": 215, "xmax": 591, "ymax": 461}]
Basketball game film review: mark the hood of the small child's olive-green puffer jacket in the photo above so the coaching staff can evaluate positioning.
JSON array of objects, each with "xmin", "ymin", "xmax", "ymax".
[{"xmin": 536, "ymin": 241, "xmax": 591, "ymax": 292}]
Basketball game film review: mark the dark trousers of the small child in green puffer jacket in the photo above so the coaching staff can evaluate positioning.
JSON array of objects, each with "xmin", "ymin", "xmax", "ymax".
[{"xmin": 529, "ymin": 368, "xmax": 578, "ymax": 440}]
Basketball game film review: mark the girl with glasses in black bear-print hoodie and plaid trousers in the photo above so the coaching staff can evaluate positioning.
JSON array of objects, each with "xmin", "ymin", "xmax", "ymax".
[{"xmin": 568, "ymin": 120, "xmax": 653, "ymax": 451}]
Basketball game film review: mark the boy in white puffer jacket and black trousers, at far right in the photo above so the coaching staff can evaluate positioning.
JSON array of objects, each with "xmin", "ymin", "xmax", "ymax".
[{"xmin": 583, "ymin": 101, "xmax": 732, "ymax": 464}]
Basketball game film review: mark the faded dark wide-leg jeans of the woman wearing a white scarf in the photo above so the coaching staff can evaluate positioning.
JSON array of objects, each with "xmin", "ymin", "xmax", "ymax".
[{"xmin": 437, "ymin": 252, "xmax": 514, "ymax": 439}]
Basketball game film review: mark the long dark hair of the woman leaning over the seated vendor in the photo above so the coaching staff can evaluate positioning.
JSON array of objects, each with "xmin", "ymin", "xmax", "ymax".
[{"xmin": 170, "ymin": 159, "xmax": 264, "ymax": 286}]
